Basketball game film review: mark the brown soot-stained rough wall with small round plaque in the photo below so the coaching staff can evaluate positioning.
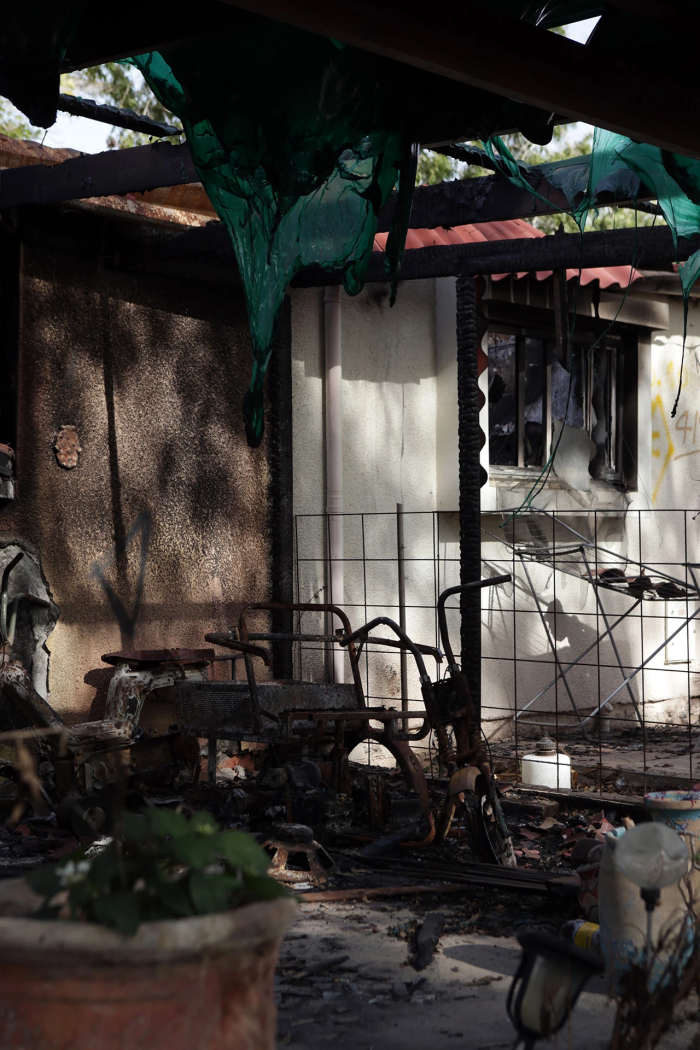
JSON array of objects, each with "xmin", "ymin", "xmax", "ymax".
[{"xmin": 0, "ymin": 247, "xmax": 270, "ymax": 720}]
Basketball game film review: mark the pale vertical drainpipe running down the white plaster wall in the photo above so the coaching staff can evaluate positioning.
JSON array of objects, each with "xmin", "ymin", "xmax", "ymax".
[{"xmin": 323, "ymin": 288, "xmax": 345, "ymax": 683}]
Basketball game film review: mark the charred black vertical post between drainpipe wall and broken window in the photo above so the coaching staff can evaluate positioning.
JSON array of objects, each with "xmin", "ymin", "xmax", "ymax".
[{"xmin": 457, "ymin": 277, "xmax": 482, "ymax": 726}]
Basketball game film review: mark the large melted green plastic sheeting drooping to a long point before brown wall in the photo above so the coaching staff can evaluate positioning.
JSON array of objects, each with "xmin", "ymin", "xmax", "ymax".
[{"xmin": 131, "ymin": 22, "xmax": 417, "ymax": 446}]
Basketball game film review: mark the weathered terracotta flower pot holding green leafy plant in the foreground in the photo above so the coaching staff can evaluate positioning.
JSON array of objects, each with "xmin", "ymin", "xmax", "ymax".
[{"xmin": 0, "ymin": 898, "xmax": 296, "ymax": 1050}]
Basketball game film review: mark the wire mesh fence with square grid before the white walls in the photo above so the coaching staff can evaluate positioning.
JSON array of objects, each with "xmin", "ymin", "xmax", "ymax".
[{"xmin": 295, "ymin": 509, "xmax": 700, "ymax": 796}]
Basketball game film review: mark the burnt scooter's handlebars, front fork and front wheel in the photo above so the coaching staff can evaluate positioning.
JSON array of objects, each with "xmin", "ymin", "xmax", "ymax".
[{"xmin": 340, "ymin": 574, "xmax": 516, "ymax": 867}]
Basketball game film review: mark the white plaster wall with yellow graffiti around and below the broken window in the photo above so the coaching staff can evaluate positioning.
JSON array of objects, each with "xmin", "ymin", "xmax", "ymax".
[{"xmin": 482, "ymin": 296, "xmax": 700, "ymax": 727}]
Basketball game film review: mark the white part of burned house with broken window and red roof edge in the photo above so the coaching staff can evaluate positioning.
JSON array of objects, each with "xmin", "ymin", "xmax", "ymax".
[{"xmin": 285, "ymin": 227, "xmax": 700, "ymax": 755}]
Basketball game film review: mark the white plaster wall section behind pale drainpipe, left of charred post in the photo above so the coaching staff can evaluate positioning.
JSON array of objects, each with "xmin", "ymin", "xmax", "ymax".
[{"xmin": 292, "ymin": 280, "xmax": 437, "ymax": 760}]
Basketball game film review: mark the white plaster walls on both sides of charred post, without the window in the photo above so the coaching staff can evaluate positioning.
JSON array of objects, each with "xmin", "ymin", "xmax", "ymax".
[{"xmin": 293, "ymin": 279, "xmax": 700, "ymax": 747}]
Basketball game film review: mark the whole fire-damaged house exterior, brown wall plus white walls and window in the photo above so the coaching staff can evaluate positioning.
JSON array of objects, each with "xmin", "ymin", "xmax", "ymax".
[{"xmin": 5, "ymin": 129, "xmax": 700, "ymax": 750}]
